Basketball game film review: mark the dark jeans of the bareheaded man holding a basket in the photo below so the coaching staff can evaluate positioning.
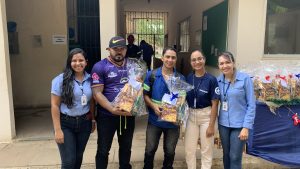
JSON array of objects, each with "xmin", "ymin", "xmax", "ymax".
[{"xmin": 144, "ymin": 123, "xmax": 179, "ymax": 169}]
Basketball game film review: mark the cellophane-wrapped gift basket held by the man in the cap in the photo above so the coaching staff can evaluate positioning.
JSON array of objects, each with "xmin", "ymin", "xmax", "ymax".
[{"xmin": 112, "ymin": 59, "xmax": 147, "ymax": 116}]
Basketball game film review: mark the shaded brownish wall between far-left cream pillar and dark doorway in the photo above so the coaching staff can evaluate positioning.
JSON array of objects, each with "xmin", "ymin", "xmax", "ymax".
[{"xmin": 6, "ymin": 0, "xmax": 67, "ymax": 108}]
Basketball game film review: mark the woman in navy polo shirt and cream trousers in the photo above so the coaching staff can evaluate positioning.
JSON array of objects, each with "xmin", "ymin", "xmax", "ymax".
[{"xmin": 184, "ymin": 50, "xmax": 220, "ymax": 169}]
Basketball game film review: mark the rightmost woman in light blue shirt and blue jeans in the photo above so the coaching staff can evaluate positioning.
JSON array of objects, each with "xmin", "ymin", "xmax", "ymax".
[{"xmin": 218, "ymin": 52, "xmax": 255, "ymax": 169}]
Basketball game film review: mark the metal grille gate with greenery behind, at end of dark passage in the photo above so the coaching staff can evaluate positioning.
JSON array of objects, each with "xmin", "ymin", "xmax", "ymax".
[{"xmin": 125, "ymin": 11, "xmax": 168, "ymax": 55}]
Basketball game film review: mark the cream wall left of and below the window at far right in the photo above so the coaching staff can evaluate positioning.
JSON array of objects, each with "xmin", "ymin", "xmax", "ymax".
[{"xmin": 228, "ymin": 0, "xmax": 300, "ymax": 66}]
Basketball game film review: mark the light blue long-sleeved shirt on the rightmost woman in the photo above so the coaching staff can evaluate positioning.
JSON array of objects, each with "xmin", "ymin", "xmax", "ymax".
[{"xmin": 218, "ymin": 72, "xmax": 256, "ymax": 129}]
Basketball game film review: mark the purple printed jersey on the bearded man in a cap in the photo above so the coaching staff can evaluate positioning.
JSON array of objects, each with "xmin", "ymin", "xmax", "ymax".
[{"xmin": 91, "ymin": 58, "xmax": 128, "ymax": 115}]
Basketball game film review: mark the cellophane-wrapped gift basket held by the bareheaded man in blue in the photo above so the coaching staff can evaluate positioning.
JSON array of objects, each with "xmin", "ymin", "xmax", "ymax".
[{"xmin": 159, "ymin": 76, "xmax": 193, "ymax": 124}]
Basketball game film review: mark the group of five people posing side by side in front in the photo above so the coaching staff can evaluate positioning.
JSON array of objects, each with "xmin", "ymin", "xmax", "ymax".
[{"xmin": 51, "ymin": 36, "xmax": 255, "ymax": 169}]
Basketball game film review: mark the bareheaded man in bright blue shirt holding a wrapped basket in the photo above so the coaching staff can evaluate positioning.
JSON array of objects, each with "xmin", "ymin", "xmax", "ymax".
[{"xmin": 144, "ymin": 47, "xmax": 184, "ymax": 169}]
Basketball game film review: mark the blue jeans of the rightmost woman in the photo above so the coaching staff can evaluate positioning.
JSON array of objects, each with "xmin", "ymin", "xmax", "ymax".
[{"xmin": 219, "ymin": 125, "xmax": 246, "ymax": 169}]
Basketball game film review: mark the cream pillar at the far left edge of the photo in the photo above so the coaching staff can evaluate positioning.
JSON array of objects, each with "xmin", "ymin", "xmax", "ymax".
[{"xmin": 0, "ymin": 1, "xmax": 16, "ymax": 142}]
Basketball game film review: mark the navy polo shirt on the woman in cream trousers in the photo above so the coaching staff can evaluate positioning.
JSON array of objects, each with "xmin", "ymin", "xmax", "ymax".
[{"xmin": 186, "ymin": 73, "xmax": 220, "ymax": 109}]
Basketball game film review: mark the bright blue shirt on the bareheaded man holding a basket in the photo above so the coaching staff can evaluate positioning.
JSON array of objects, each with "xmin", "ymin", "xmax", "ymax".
[{"xmin": 144, "ymin": 67, "xmax": 185, "ymax": 128}]
